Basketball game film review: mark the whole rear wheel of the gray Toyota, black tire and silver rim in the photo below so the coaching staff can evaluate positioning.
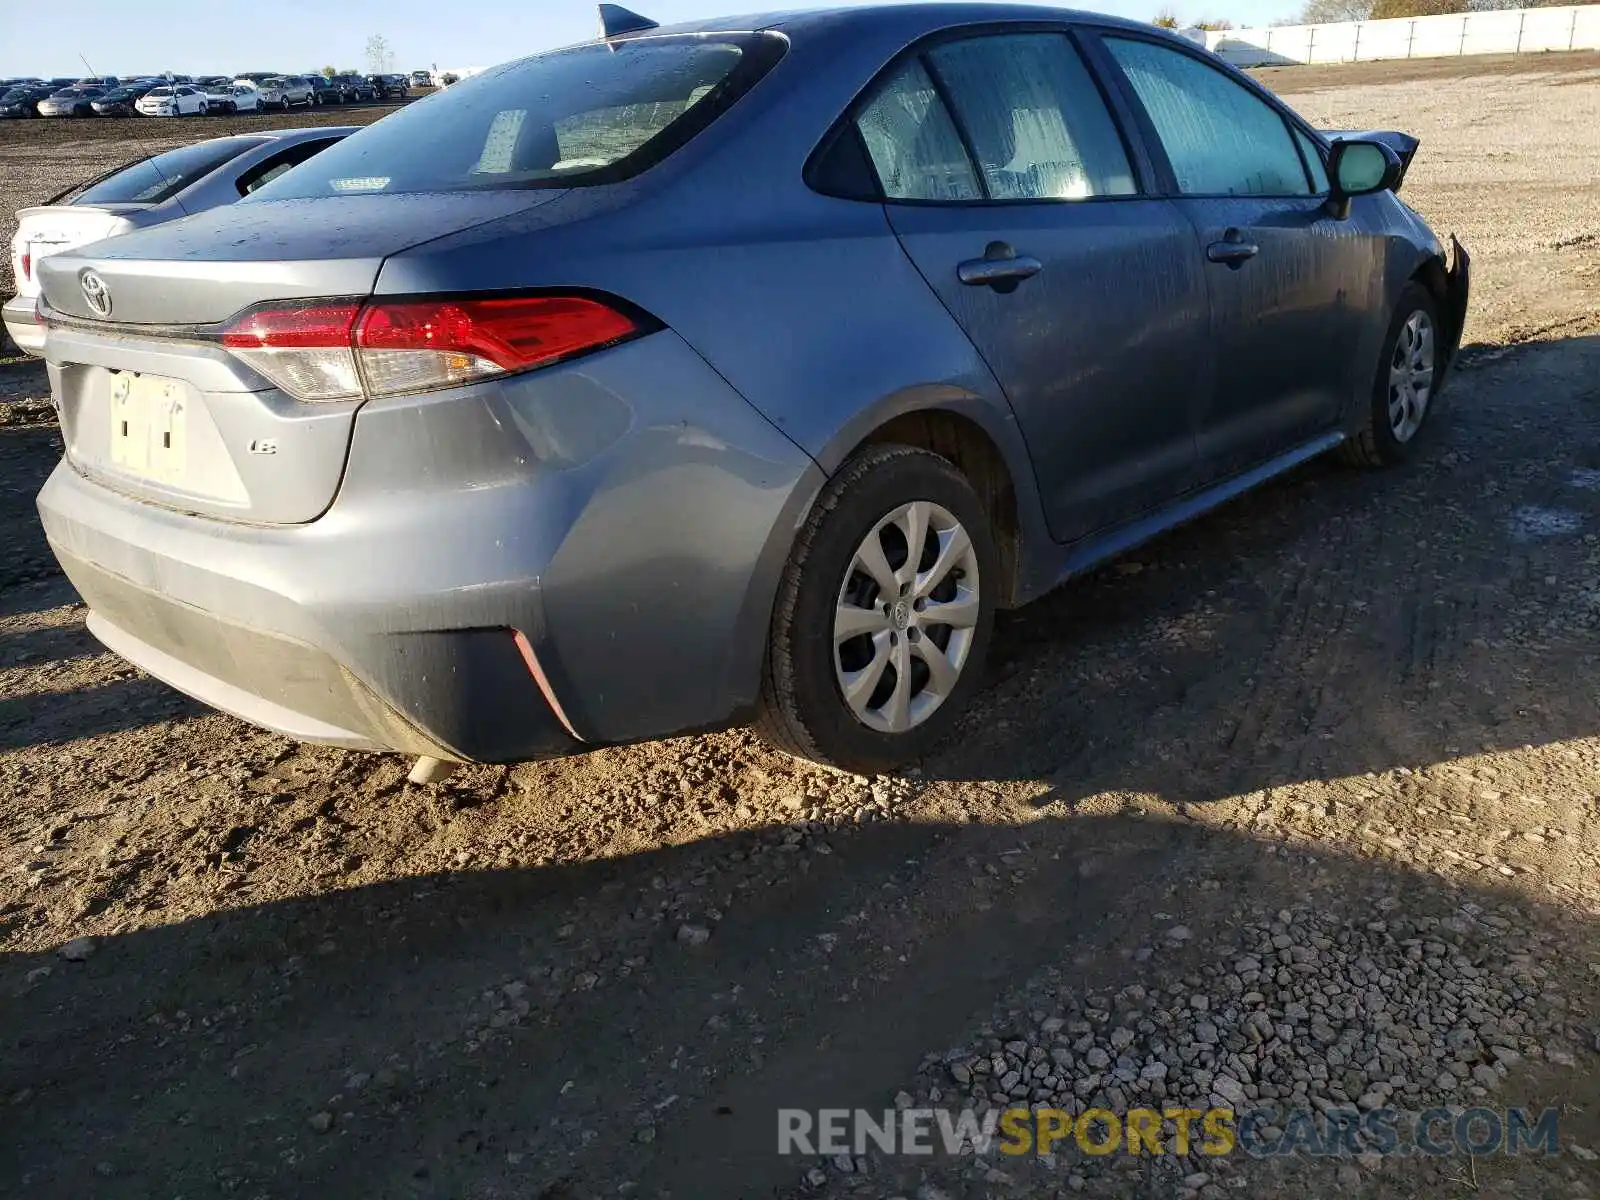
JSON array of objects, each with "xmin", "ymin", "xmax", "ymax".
[{"xmin": 757, "ymin": 445, "xmax": 1000, "ymax": 774}]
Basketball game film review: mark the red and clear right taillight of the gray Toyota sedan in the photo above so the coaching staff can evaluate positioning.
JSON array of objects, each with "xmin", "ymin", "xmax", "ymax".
[{"xmin": 222, "ymin": 296, "xmax": 642, "ymax": 400}]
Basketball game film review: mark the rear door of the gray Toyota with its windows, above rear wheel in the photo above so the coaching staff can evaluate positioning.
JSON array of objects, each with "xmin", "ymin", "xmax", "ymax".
[{"xmin": 858, "ymin": 27, "xmax": 1208, "ymax": 541}]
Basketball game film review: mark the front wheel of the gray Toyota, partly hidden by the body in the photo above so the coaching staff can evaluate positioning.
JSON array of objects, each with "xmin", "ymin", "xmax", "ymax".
[{"xmin": 1339, "ymin": 280, "xmax": 1445, "ymax": 467}]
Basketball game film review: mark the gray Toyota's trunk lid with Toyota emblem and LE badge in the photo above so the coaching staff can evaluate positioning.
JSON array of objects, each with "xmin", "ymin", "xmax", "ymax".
[{"xmin": 38, "ymin": 190, "xmax": 560, "ymax": 523}]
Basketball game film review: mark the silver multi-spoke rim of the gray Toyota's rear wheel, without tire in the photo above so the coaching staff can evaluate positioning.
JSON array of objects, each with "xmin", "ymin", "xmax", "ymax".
[{"xmin": 834, "ymin": 501, "xmax": 981, "ymax": 733}]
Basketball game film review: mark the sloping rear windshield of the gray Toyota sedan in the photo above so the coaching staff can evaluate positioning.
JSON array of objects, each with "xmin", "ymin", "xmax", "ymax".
[{"xmin": 250, "ymin": 34, "xmax": 784, "ymax": 202}]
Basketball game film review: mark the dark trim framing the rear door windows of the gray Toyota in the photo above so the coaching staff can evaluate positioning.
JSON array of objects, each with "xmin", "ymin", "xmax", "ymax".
[{"xmin": 802, "ymin": 21, "xmax": 1160, "ymax": 208}]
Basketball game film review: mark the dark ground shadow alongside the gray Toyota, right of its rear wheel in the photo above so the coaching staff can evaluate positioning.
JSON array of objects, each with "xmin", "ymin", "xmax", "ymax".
[{"xmin": 922, "ymin": 336, "xmax": 1600, "ymax": 803}]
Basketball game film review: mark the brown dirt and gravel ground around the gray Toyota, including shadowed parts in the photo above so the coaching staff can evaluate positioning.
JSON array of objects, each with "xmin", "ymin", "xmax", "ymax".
[{"xmin": 0, "ymin": 56, "xmax": 1600, "ymax": 1200}]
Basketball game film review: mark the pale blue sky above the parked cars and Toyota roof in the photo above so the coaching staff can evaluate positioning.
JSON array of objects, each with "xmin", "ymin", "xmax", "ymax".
[{"xmin": 0, "ymin": 0, "xmax": 1299, "ymax": 78}]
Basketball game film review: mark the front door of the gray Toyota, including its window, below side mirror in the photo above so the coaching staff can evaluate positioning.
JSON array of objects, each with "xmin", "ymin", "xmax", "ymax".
[{"xmin": 1102, "ymin": 30, "xmax": 1376, "ymax": 477}]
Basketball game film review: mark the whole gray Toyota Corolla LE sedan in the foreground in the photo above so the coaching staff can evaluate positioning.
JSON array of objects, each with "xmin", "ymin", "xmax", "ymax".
[{"xmin": 38, "ymin": 5, "xmax": 1467, "ymax": 778}]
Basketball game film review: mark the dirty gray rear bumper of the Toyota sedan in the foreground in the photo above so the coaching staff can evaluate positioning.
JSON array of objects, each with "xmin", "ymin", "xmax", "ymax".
[{"xmin": 38, "ymin": 333, "xmax": 822, "ymax": 762}]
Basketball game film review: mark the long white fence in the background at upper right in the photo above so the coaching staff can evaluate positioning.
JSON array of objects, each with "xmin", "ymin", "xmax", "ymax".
[{"xmin": 1205, "ymin": 5, "xmax": 1600, "ymax": 67}]
